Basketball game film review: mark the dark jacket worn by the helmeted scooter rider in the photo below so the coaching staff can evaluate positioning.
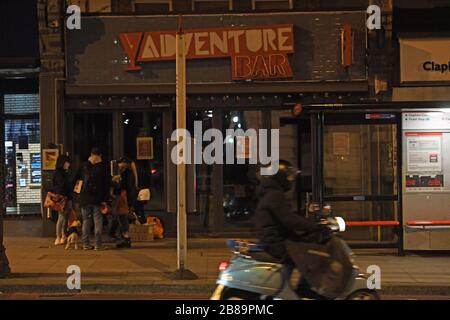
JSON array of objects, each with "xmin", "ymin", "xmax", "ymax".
[{"xmin": 255, "ymin": 178, "xmax": 321, "ymax": 260}]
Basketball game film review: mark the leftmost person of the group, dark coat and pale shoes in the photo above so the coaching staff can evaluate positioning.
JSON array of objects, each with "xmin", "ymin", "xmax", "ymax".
[{"xmin": 52, "ymin": 155, "xmax": 73, "ymax": 245}]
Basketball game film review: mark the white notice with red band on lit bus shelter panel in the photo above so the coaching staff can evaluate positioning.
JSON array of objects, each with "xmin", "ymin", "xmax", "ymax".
[{"xmin": 405, "ymin": 132, "xmax": 444, "ymax": 191}]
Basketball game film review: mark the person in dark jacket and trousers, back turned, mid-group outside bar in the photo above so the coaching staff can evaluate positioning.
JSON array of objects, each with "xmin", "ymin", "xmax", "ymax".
[{"xmin": 77, "ymin": 148, "xmax": 110, "ymax": 250}]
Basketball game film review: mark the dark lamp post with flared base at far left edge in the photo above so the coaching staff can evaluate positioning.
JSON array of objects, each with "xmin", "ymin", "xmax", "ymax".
[{"xmin": 0, "ymin": 97, "xmax": 11, "ymax": 278}]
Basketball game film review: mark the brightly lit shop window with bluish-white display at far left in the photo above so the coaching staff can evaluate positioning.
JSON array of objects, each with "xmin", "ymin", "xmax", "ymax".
[{"xmin": 4, "ymin": 94, "xmax": 41, "ymax": 215}]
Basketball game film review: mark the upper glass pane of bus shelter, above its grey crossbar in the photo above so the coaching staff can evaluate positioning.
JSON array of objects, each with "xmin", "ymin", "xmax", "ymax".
[{"xmin": 323, "ymin": 124, "xmax": 398, "ymax": 196}]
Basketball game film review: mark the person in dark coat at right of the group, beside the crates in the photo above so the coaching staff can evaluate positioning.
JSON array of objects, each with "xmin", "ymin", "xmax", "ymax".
[{"xmin": 113, "ymin": 157, "xmax": 138, "ymax": 248}]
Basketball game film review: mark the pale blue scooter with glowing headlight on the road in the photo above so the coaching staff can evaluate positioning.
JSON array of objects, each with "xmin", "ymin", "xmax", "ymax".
[{"xmin": 211, "ymin": 208, "xmax": 380, "ymax": 300}]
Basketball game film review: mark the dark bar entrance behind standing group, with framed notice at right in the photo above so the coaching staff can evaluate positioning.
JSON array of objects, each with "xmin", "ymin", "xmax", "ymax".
[{"xmin": 66, "ymin": 110, "xmax": 165, "ymax": 213}]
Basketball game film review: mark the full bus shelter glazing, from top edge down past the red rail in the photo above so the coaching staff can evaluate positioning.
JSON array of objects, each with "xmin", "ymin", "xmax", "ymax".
[{"xmin": 322, "ymin": 114, "xmax": 398, "ymax": 241}]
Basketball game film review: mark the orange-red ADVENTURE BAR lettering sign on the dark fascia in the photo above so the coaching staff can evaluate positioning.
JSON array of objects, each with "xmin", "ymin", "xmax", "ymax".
[{"xmin": 119, "ymin": 25, "xmax": 294, "ymax": 80}]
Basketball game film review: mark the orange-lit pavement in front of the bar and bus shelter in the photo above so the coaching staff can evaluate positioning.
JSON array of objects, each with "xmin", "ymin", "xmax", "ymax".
[{"xmin": 0, "ymin": 237, "xmax": 450, "ymax": 296}]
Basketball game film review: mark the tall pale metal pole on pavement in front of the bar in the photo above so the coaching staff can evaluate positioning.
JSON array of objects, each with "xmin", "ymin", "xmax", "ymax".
[{"xmin": 172, "ymin": 18, "xmax": 198, "ymax": 280}]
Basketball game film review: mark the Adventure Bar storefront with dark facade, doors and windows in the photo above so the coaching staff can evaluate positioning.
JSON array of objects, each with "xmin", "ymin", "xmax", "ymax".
[{"xmin": 42, "ymin": 11, "xmax": 368, "ymax": 234}]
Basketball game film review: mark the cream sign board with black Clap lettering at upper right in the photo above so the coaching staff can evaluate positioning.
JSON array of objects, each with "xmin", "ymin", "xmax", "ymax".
[{"xmin": 400, "ymin": 38, "xmax": 450, "ymax": 82}]
